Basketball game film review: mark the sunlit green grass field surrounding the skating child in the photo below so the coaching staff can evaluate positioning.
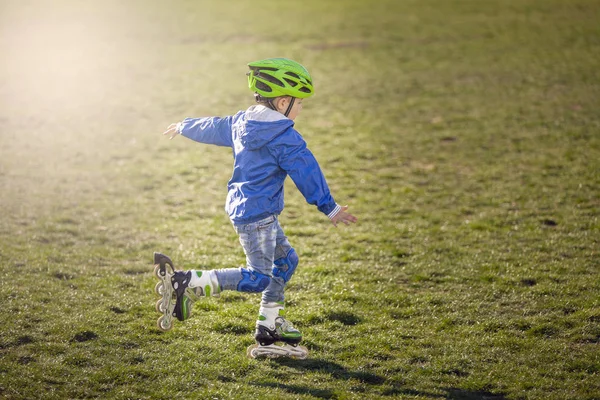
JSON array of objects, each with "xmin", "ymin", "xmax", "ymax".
[{"xmin": 0, "ymin": 0, "xmax": 600, "ymax": 400}]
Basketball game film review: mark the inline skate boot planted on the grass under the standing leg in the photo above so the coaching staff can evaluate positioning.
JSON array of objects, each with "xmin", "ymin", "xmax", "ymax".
[{"xmin": 248, "ymin": 303, "xmax": 308, "ymax": 359}]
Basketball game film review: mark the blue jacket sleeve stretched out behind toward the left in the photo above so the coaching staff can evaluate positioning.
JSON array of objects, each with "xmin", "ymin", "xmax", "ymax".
[{"xmin": 177, "ymin": 116, "xmax": 233, "ymax": 147}]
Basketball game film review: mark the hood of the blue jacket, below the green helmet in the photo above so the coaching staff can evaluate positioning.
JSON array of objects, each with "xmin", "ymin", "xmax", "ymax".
[{"xmin": 238, "ymin": 105, "xmax": 294, "ymax": 150}]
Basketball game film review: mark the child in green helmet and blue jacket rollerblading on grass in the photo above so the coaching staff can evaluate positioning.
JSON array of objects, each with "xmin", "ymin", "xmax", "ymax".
[{"xmin": 155, "ymin": 58, "xmax": 356, "ymax": 358}]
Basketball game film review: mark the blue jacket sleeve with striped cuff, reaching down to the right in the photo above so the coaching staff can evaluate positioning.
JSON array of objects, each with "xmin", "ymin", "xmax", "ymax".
[{"xmin": 269, "ymin": 129, "xmax": 340, "ymax": 218}]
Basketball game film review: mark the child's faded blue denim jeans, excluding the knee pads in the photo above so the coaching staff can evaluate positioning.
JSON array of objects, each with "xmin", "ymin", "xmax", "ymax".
[{"xmin": 217, "ymin": 215, "xmax": 292, "ymax": 303}]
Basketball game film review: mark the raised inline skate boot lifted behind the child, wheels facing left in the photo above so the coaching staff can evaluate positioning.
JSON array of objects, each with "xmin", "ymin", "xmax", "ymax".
[{"xmin": 154, "ymin": 253, "xmax": 221, "ymax": 331}]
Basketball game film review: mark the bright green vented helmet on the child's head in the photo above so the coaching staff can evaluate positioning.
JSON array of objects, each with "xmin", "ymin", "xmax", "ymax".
[{"xmin": 247, "ymin": 58, "xmax": 315, "ymax": 99}]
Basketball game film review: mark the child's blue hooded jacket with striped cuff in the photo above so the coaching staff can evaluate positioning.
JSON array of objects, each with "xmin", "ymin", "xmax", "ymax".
[{"xmin": 178, "ymin": 105, "xmax": 339, "ymax": 225}]
